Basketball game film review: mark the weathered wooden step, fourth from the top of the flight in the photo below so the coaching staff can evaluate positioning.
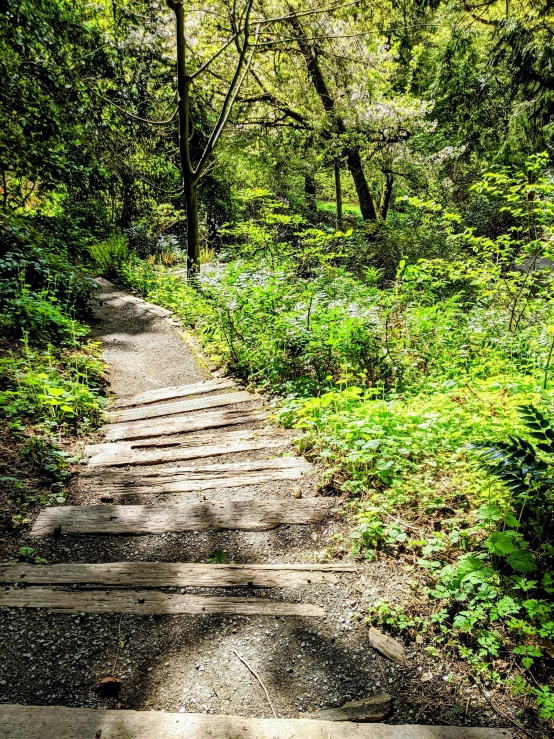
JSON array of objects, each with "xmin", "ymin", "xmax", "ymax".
[{"xmin": 86, "ymin": 429, "xmax": 288, "ymax": 467}]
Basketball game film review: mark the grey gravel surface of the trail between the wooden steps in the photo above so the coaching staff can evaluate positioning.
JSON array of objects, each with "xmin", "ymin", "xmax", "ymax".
[{"xmin": 0, "ymin": 282, "xmax": 517, "ymax": 726}]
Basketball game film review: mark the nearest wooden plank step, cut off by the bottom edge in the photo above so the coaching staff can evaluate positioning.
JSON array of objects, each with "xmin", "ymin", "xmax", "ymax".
[{"xmin": 0, "ymin": 705, "xmax": 513, "ymax": 739}]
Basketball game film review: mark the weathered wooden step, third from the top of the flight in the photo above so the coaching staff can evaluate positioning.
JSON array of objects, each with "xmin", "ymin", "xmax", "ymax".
[{"xmin": 103, "ymin": 409, "xmax": 267, "ymax": 441}]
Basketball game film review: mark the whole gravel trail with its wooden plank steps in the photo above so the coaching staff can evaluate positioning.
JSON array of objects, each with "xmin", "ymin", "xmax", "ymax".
[{"xmin": 0, "ymin": 281, "xmax": 508, "ymax": 739}]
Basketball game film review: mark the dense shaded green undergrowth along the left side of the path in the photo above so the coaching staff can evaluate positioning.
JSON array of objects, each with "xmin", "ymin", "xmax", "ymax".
[{"xmin": 0, "ymin": 214, "xmax": 104, "ymax": 557}]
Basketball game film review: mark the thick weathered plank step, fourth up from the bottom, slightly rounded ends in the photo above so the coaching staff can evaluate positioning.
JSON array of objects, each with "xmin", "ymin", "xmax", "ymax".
[{"xmin": 31, "ymin": 498, "xmax": 337, "ymax": 536}]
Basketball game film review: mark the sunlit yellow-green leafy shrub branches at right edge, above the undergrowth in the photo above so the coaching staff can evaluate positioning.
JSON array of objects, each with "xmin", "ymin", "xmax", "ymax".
[{"xmin": 398, "ymin": 153, "xmax": 554, "ymax": 332}]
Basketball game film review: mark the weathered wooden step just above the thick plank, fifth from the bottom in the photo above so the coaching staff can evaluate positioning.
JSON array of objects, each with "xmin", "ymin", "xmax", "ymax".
[{"xmin": 80, "ymin": 457, "xmax": 313, "ymax": 496}]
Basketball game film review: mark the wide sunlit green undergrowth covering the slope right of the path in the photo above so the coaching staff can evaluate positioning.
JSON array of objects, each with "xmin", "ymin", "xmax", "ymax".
[{"xmin": 114, "ymin": 157, "xmax": 554, "ymax": 720}]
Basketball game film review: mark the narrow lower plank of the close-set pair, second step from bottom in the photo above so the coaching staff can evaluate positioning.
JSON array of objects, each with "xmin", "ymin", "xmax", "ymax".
[{"xmin": 0, "ymin": 586, "xmax": 325, "ymax": 618}]
